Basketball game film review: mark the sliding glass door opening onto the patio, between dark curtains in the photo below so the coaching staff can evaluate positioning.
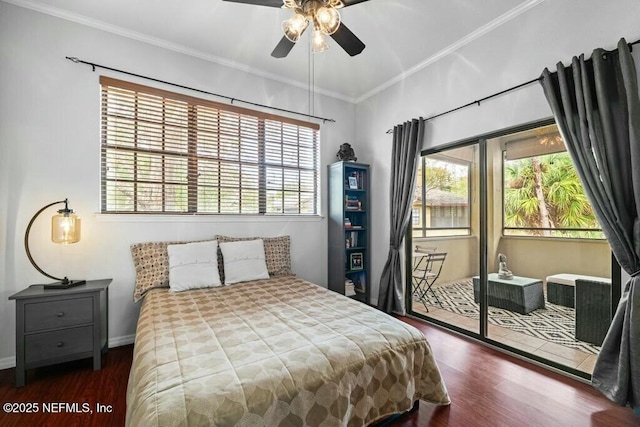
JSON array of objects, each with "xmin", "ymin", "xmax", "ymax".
[{"xmin": 407, "ymin": 121, "xmax": 620, "ymax": 378}]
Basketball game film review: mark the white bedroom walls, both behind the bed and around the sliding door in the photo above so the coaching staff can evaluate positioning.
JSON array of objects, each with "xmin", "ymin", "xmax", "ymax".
[{"xmin": 0, "ymin": 0, "xmax": 640, "ymax": 367}]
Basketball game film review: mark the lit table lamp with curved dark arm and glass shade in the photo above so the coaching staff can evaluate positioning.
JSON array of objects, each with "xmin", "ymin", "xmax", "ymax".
[{"xmin": 24, "ymin": 199, "xmax": 86, "ymax": 289}]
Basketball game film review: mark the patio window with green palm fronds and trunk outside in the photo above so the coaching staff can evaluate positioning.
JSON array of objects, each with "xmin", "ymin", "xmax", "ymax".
[{"xmin": 502, "ymin": 125, "xmax": 604, "ymax": 239}]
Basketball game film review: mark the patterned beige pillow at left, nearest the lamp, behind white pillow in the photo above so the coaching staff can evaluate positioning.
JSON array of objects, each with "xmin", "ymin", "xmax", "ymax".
[{"xmin": 131, "ymin": 242, "xmax": 218, "ymax": 302}]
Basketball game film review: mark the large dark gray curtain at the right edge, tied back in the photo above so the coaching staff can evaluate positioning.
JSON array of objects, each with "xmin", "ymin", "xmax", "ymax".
[{"xmin": 542, "ymin": 39, "xmax": 640, "ymax": 412}]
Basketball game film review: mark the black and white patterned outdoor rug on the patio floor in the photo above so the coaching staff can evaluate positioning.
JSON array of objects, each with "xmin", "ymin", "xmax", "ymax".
[{"xmin": 414, "ymin": 279, "xmax": 600, "ymax": 354}]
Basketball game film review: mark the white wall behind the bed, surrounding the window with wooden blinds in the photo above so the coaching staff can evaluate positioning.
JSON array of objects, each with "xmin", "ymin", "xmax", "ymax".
[{"xmin": 0, "ymin": 2, "xmax": 355, "ymax": 368}]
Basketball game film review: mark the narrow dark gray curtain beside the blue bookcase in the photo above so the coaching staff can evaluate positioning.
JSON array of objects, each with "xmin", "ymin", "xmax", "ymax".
[{"xmin": 378, "ymin": 118, "xmax": 424, "ymax": 314}]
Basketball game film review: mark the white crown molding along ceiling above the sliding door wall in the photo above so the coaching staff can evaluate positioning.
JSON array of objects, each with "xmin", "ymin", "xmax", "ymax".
[{"xmin": 355, "ymin": 0, "xmax": 545, "ymax": 104}]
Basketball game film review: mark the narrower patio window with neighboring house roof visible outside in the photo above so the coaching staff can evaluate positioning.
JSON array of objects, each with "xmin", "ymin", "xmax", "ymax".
[{"xmin": 413, "ymin": 147, "xmax": 473, "ymax": 238}]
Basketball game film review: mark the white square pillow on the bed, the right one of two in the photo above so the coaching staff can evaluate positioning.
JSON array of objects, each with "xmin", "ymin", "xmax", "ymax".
[{"xmin": 220, "ymin": 239, "xmax": 269, "ymax": 285}]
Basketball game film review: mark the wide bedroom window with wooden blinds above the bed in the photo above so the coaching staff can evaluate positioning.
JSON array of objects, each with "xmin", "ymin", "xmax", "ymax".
[{"xmin": 100, "ymin": 77, "xmax": 319, "ymax": 215}]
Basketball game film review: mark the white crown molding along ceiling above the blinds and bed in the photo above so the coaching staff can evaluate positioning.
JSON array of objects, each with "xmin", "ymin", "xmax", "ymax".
[{"xmin": 0, "ymin": 0, "xmax": 355, "ymax": 104}]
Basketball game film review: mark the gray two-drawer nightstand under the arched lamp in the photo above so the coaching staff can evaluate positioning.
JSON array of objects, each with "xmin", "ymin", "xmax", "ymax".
[{"xmin": 9, "ymin": 279, "xmax": 111, "ymax": 387}]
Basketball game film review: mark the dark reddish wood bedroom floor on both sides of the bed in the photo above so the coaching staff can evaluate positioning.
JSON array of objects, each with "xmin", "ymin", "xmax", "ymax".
[{"xmin": 0, "ymin": 318, "xmax": 640, "ymax": 427}]
